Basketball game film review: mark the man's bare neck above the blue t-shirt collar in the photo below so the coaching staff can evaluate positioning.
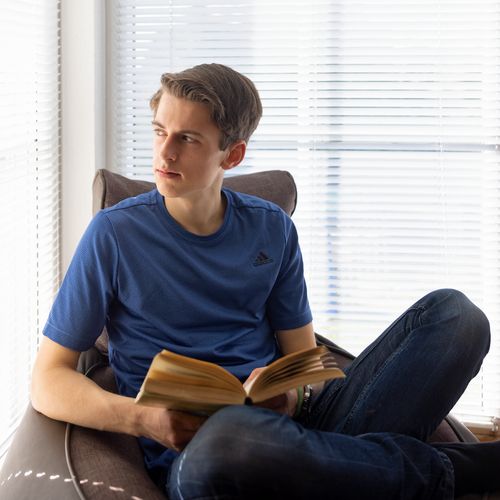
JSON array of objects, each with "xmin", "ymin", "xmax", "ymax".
[{"xmin": 164, "ymin": 190, "xmax": 227, "ymax": 236}]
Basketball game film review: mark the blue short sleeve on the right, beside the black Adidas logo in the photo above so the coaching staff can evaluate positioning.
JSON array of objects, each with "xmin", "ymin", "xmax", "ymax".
[{"xmin": 267, "ymin": 216, "xmax": 312, "ymax": 331}]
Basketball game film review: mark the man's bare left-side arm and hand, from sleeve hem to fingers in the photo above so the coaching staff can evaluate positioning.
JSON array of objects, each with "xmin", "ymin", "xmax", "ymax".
[{"xmin": 31, "ymin": 337, "xmax": 204, "ymax": 449}]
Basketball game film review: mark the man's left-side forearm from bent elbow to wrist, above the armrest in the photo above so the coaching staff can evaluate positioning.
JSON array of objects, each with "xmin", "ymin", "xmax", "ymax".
[{"xmin": 31, "ymin": 366, "xmax": 142, "ymax": 436}]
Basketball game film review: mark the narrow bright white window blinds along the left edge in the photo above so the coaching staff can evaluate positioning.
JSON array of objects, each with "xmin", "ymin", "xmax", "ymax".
[{"xmin": 0, "ymin": 0, "xmax": 59, "ymax": 457}]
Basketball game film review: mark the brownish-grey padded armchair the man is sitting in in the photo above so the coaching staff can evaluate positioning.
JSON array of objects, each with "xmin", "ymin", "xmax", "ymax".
[{"xmin": 0, "ymin": 170, "xmax": 488, "ymax": 500}]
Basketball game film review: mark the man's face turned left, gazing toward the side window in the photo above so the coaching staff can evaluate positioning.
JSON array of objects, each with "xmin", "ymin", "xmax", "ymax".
[{"xmin": 153, "ymin": 92, "xmax": 227, "ymax": 198}]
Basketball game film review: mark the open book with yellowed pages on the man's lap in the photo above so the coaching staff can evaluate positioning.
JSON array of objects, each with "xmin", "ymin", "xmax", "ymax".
[{"xmin": 135, "ymin": 346, "xmax": 344, "ymax": 414}]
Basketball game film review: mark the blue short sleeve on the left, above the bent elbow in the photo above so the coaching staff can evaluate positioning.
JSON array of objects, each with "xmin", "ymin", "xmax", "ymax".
[{"xmin": 43, "ymin": 212, "xmax": 119, "ymax": 351}]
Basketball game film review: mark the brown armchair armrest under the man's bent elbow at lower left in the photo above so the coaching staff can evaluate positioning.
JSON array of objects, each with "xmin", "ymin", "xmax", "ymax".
[{"xmin": 0, "ymin": 349, "xmax": 166, "ymax": 500}]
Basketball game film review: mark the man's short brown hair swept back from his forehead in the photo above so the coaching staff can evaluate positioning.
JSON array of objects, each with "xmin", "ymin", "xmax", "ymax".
[{"xmin": 149, "ymin": 64, "xmax": 262, "ymax": 150}]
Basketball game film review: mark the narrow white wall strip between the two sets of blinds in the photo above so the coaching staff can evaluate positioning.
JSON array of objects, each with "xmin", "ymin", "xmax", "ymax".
[{"xmin": 61, "ymin": 0, "xmax": 106, "ymax": 273}]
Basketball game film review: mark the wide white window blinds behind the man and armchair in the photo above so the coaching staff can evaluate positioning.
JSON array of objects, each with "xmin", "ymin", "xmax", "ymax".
[{"xmin": 109, "ymin": 0, "xmax": 500, "ymax": 428}]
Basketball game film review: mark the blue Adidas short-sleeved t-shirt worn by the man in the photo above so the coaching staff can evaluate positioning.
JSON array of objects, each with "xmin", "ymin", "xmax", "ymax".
[{"xmin": 44, "ymin": 189, "xmax": 311, "ymax": 472}]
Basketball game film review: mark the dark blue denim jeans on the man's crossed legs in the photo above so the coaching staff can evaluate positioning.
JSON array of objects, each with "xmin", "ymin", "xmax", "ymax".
[{"xmin": 167, "ymin": 290, "xmax": 490, "ymax": 500}]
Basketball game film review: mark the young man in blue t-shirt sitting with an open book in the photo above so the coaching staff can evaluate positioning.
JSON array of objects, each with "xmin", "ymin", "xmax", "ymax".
[{"xmin": 32, "ymin": 64, "xmax": 500, "ymax": 499}]
